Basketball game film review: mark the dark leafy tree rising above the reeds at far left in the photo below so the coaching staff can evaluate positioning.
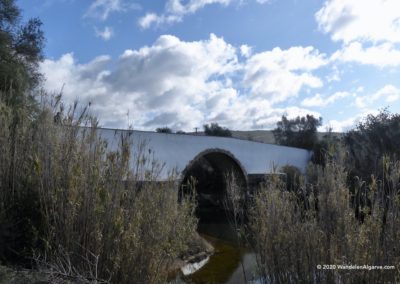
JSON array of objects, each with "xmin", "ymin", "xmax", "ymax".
[{"xmin": 0, "ymin": 0, "xmax": 44, "ymax": 106}]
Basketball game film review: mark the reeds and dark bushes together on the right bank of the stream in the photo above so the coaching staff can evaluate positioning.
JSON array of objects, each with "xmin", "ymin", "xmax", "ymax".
[{"xmin": 227, "ymin": 110, "xmax": 400, "ymax": 283}]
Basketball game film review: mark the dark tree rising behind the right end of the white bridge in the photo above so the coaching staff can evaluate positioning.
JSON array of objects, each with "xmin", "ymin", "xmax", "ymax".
[{"xmin": 272, "ymin": 115, "xmax": 322, "ymax": 150}]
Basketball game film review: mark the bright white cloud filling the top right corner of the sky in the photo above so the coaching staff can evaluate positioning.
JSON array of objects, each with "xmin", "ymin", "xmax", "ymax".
[{"xmin": 315, "ymin": 0, "xmax": 400, "ymax": 44}]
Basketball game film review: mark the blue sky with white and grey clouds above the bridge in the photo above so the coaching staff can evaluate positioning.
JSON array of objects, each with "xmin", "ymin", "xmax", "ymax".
[{"xmin": 17, "ymin": 0, "xmax": 400, "ymax": 131}]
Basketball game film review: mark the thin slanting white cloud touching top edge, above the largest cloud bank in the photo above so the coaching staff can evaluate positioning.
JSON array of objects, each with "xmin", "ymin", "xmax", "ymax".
[{"xmin": 138, "ymin": 0, "xmax": 270, "ymax": 29}]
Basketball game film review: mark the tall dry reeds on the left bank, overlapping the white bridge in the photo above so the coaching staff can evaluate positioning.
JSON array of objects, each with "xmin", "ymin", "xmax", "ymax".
[{"xmin": 0, "ymin": 94, "xmax": 197, "ymax": 283}]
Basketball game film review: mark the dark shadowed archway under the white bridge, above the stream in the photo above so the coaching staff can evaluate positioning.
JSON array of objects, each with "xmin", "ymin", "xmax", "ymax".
[{"xmin": 179, "ymin": 148, "xmax": 248, "ymax": 222}]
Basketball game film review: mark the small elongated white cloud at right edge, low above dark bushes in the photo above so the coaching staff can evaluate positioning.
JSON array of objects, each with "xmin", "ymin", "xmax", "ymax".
[{"xmin": 354, "ymin": 85, "xmax": 400, "ymax": 109}]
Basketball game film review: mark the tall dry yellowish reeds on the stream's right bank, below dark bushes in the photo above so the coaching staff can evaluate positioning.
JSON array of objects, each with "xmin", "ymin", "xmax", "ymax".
[{"xmin": 249, "ymin": 153, "xmax": 400, "ymax": 283}]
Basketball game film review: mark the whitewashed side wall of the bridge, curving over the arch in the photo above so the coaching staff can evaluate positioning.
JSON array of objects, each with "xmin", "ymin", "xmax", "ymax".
[{"xmin": 99, "ymin": 129, "xmax": 310, "ymax": 179}]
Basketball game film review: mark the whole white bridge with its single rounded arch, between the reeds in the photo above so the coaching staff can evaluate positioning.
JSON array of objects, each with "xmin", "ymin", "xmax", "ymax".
[{"xmin": 99, "ymin": 128, "xmax": 311, "ymax": 189}]
